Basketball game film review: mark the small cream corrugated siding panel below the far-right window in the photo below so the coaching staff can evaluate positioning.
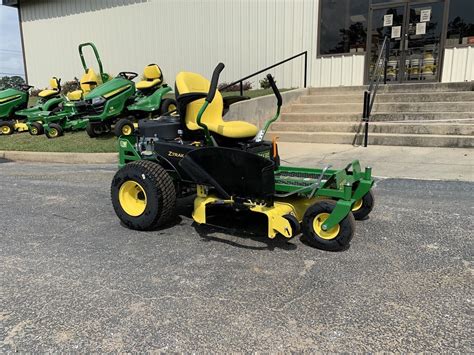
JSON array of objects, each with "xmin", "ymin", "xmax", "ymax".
[{"xmin": 441, "ymin": 47, "xmax": 474, "ymax": 83}]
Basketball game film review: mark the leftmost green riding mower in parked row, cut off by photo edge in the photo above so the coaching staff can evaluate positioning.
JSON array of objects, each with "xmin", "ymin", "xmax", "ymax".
[{"xmin": 0, "ymin": 77, "xmax": 65, "ymax": 135}]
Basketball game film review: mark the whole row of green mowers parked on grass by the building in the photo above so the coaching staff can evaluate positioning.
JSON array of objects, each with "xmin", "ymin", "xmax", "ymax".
[{"xmin": 0, "ymin": 43, "xmax": 176, "ymax": 138}]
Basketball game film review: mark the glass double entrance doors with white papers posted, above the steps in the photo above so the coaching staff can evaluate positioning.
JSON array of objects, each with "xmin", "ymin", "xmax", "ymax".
[{"xmin": 368, "ymin": 0, "xmax": 446, "ymax": 83}]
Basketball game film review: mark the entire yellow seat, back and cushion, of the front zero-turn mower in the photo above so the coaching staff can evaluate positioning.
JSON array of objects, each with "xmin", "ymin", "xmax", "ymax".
[{"xmin": 176, "ymin": 72, "xmax": 258, "ymax": 139}]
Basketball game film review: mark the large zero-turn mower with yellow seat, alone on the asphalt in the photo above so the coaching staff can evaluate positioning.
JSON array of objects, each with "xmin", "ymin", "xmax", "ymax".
[{"xmin": 111, "ymin": 63, "xmax": 374, "ymax": 250}]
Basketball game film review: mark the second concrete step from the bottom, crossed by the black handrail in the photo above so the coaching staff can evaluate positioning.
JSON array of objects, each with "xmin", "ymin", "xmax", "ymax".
[{"xmin": 271, "ymin": 122, "xmax": 474, "ymax": 136}]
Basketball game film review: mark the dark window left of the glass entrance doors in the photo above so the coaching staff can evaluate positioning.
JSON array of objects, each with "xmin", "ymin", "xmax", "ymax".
[{"xmin": 319, "ymin": 0, "xmax": 369, "ymax": 55}]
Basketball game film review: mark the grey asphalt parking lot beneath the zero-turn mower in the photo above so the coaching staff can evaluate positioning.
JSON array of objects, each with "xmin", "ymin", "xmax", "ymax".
[{"xmin": 0, "ymin": 162, "xmax": 474, "ymax": 353}]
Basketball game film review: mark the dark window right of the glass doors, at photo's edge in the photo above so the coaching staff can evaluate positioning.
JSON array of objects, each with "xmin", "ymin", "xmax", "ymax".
[{"xmin": 446, "ymin": 0, "xmax": 474, "ymax": 46}]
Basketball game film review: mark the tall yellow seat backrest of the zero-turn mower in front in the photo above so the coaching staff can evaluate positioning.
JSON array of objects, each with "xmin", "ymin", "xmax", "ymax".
[{"xmin": 176, "ymin": 72, "xmax": 224, "ymax": 128}]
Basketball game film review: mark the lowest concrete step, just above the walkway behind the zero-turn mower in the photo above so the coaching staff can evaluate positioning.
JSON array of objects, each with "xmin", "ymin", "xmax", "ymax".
[{"xmin": 267, "ymin": 131, "xmax": 474, "ymax": 148}]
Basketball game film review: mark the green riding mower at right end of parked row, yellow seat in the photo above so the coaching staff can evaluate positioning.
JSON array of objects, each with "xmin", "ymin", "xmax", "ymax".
[{"xmin": 79, "ymin": 64, "xmax": 176, "ymax": 138}]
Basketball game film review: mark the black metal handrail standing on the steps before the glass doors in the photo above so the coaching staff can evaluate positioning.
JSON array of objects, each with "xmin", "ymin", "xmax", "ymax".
[{"xmin": 362, "ymin": 36, "xmax": 390, "ymax": 147}]
